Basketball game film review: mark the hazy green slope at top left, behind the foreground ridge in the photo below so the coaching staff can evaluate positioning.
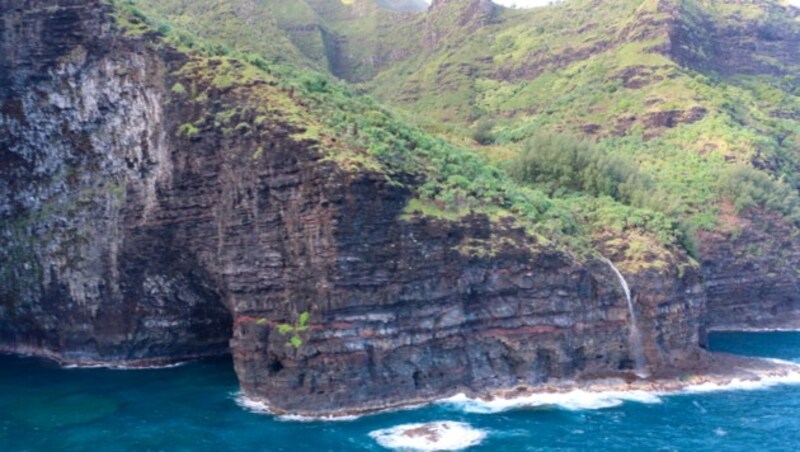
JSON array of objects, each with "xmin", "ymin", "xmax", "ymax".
[{"xmin": 131, "ymin": 0, "xmax": 428, "ymax": 81}]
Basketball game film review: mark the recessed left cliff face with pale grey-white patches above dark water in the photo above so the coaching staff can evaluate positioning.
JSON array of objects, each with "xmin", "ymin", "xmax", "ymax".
[{"xmin": 0, "ymin": 0, "xmax": 230, "ymax": 361}]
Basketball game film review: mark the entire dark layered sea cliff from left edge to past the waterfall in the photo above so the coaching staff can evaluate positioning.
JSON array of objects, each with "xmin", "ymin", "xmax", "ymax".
[{"xmin": 0, "ymin": 0, "xmax": 705, "ymax": 414}]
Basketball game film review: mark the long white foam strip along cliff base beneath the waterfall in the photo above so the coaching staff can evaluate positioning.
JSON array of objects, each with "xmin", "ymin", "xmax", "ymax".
[{"xmin": 441, "ymin": 390, "xmax": 661, "ymax": 414}]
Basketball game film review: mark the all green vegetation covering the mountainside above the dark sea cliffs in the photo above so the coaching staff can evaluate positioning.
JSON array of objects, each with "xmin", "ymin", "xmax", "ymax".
[{"xmin": 106, "ymin": 0, "xmax": 800, "ymax": 262}]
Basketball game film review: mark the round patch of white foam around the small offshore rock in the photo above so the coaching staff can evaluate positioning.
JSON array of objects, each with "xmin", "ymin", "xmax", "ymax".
[{"xmin": 369, "ymin": 421, "xmax": 488, "ymax": 451}]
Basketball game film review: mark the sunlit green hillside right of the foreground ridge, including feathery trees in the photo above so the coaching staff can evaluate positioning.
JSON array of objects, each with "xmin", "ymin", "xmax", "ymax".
[{"xmin": 369, "ymin": 0, "xmax": 800, "ymax": 260}]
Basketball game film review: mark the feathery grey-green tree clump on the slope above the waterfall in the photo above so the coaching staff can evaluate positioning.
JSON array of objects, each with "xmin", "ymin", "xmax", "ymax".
[{"xmin": 507, "ymin": 133, "xmax": 697, "ymax": 257}]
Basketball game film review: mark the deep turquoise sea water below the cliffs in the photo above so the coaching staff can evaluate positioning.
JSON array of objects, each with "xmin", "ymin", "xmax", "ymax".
[{"xmin": 0, "ymin": 333, "xmax": 800, "ymax": 452}]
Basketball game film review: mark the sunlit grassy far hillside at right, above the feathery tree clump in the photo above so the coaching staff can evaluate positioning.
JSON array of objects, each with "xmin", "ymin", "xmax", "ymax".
[{"xmin": 370, "ymin": 0, "xmax": 800, "ymax": 240}]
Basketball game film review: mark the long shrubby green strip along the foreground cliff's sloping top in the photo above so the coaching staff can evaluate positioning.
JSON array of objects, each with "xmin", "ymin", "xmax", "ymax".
[{"xmin": 115, "ymin": 0, "xmax": 676, "ymax": 262}]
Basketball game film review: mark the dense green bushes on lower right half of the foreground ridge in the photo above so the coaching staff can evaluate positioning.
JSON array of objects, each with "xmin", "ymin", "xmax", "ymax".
[{"xmin": 282, "ymin": 67, "xmax": 575, "ymax": 245}]
